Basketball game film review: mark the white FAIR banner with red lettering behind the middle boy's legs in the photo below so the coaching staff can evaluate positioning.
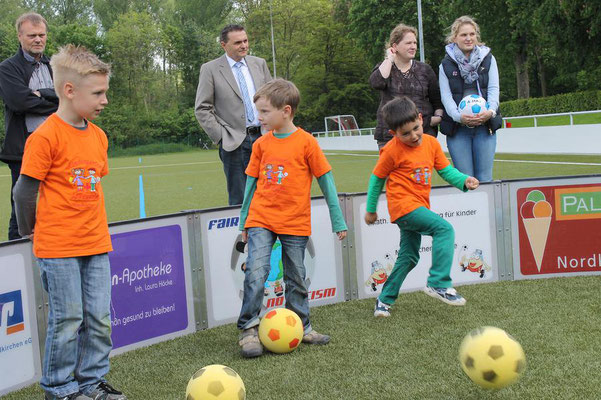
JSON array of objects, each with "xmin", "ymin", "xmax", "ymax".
[{"xmin": 201, "ymin": 199, "xmax": 344, "ymax": 328}]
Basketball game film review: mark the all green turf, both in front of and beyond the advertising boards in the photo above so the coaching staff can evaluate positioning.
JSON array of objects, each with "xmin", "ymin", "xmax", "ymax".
[{"xmin": 0, "ymin": 151, "xmax": 601, "ymax": 400}]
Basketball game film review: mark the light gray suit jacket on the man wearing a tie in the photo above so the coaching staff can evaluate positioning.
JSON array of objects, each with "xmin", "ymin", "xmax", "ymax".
[{"xmin": 194, "ymin": 54, "xmax": 271, "ymax": 151}]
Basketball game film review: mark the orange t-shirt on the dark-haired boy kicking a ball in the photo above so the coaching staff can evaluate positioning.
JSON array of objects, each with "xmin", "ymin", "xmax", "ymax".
[{"xmin": 373, "ymin": 134, "xmax": 450, "ymax": 222}]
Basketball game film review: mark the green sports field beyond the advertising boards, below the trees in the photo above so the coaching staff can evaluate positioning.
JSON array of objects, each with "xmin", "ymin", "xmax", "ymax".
[{"xmin": 0, "ymin": 150, "xmax": 601, "ymax": 240}]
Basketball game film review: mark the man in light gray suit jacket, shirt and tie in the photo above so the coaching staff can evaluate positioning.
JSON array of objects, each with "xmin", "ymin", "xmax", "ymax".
[{"xmin": 195, "ymin": 25, "xmax": 271, "ymax": 205}]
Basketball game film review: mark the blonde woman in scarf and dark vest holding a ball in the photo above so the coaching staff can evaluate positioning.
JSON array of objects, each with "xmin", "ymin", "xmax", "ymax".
[{"xmin": 438, "ymin": 16, "xmax": 501, "ymax": 182}]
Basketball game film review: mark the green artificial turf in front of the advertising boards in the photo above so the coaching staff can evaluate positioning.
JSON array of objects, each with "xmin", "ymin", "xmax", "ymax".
[{"xmin": 5, "ymin": 276, "xmax": 601, "ymax": 400}]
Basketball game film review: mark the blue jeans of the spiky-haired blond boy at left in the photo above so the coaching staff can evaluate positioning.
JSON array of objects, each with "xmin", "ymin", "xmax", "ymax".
[{"xmin": 38, "ymin": 253, "xmax": 112, "ymax": 398}]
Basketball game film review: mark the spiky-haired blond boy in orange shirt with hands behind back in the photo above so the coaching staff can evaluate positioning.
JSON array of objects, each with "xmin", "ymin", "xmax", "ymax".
[{"xmin": 14, "ymin": 45, "xmax": 126, "ymax": 400}]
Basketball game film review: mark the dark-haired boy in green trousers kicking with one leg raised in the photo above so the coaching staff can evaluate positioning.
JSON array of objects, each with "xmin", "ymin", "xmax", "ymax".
[{"xmin": 365, "ymin": 97, "xmax": 479, "ymax": 317}]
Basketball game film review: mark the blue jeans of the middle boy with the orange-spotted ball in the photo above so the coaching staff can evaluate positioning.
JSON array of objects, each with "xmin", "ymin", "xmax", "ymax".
[{"xmin": 238, "ymin": 228, "xmax": 312, "ymax": 334}]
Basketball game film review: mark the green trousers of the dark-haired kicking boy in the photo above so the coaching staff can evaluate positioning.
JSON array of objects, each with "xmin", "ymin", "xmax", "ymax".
[{"xmin": 379, "ymin": 207, "xmax": 455, "ymax": 305}]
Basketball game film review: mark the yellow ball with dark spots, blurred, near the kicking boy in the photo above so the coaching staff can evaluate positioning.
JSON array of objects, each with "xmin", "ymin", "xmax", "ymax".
[{"xmin": 459, "ymin": 326, "xmax": 526, "ymax": 389}]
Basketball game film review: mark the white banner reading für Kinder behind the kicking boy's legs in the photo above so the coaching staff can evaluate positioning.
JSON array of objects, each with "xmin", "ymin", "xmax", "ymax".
[{"xmin": 353, "ymin": 185, "xmax": 498, "ymax": 298}]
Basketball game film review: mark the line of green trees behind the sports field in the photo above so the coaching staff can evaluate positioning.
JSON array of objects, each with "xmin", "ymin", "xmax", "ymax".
[{"xmin": 0, "ymin": 0, "xmax": 601, "ymax": 147}]
